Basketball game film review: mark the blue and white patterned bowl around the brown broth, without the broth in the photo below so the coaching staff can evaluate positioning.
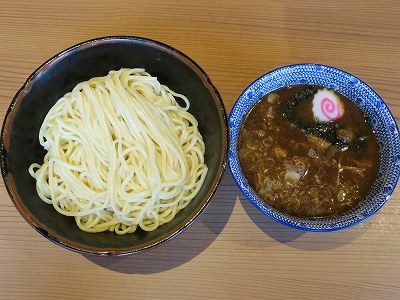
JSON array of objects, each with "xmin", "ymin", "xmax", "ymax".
[{"xmin": 229, "ymin": 64, "xmax": 400, "ymax": 231}]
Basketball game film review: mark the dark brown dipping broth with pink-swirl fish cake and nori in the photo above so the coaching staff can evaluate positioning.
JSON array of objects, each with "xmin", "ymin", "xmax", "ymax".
[{"xmin": 238, "ymin": 85, "xmax": 379, "ymax": 218}]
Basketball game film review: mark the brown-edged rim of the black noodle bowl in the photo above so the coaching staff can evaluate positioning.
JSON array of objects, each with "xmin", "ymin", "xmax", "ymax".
[{"xmin": 0, "ymin": 35, "xmax": 229, "ymax": 256}]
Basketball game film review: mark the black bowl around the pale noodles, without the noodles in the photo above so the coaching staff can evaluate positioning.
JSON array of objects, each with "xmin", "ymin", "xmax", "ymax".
[{"xmin": 1, "ymin": 37, "xmax": 227, "ymax": 255}]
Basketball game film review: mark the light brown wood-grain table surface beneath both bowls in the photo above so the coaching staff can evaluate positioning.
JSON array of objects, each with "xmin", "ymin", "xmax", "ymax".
[{"xmin": 0, "ymin": 0, "xmax": 400, "ymax": 299}]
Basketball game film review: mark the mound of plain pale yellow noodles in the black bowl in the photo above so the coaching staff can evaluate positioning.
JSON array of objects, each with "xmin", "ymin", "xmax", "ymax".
[{"xmin": 29, "ymin": 69, "xmax": 207, "ymax": 234}]
